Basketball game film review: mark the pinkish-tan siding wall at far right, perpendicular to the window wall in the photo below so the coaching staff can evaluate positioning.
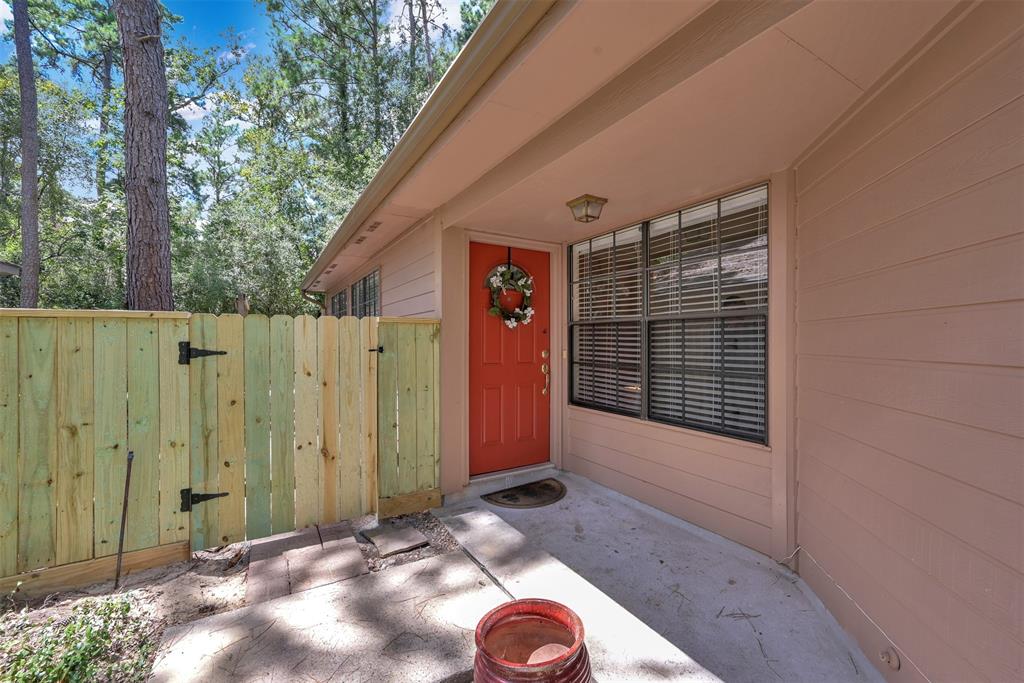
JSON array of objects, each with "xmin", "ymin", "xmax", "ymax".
[{"xmin": 797, "ymin": 3, "xmax": 1024, "ymax": 682}]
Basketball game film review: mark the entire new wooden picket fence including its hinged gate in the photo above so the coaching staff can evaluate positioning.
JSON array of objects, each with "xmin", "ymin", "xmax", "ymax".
[{"xmin": 0, "ymin": 310, "xmax": 440, "ymax": 590}]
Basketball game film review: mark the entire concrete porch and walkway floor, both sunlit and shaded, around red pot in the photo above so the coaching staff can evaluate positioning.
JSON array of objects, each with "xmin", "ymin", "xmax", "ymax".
[{"xmin": 151, "ymin": 473, "xmax": 882, "ymax": 683}]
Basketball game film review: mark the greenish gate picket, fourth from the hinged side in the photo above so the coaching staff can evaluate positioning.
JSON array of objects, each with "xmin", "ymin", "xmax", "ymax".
[{"xmin": 270, "ymin": 315, "xmax": 295, "ymax": 533}]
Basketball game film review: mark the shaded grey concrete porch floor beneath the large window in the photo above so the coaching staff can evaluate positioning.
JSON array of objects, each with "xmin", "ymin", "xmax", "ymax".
[{"xmin": 458, "ymin": 472, "xmax": 884, "ymax": 683}]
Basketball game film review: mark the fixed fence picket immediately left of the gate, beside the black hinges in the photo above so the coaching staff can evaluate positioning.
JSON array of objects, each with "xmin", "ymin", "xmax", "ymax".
[{"xmin": 159, "ymin": 318, "xmax": 189, "ymax": 545}]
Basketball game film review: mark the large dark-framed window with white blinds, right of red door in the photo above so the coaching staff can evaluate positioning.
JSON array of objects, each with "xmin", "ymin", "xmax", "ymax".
[{"xmin": 569, "ymin": 186, "xmax": 768, "ymax": 442}]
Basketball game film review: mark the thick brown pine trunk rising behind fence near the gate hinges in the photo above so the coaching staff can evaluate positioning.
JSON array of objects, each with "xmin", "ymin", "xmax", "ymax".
[{"xmin": 114, "ymin": 0, "xmax": 174, "ymax": 310}]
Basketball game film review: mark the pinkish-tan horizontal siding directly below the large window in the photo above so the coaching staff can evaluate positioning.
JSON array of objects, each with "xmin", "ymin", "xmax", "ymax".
[{"xmin": 562, "ymin": 405, "xmax": 771, "ymax": 554}]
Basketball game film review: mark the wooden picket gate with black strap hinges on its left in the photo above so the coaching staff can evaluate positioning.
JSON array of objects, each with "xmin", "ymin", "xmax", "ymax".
[{"xmin": 181, "ymin": 313, "xmax": 376, "ymax": 549}]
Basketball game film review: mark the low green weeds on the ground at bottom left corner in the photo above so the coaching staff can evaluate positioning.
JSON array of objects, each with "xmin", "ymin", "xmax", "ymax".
[{"xmin": 0, "ymin": 598, "xmax": 157, "ymax": 683}]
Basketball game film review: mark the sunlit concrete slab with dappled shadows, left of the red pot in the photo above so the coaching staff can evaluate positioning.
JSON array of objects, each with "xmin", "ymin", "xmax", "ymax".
[{"xmin": 151, "ymin": 553, "xmax": 507, "ymax": 683}]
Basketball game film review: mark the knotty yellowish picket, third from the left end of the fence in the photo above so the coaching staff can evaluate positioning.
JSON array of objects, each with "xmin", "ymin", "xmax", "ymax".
[{"xmin": 55, "ymin": 317, "xmax": 95, "ymax": 564}]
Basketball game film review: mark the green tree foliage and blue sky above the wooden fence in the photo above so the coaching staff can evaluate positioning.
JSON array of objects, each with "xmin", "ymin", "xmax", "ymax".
[{"xmin": 0, "ymin": 0, "xmax": 494, "ymax": 314}]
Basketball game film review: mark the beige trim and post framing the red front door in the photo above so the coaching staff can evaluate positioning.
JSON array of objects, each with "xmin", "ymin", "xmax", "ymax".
[{"xmin": 441, "ymin": 226, "xmax": 567, "ymax": 494}]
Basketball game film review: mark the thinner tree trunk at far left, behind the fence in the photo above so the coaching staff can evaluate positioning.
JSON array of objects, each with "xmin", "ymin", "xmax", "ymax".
[{"xmin": 13, "ymin": 0, "xmax": 39, "ymax": 308}]
